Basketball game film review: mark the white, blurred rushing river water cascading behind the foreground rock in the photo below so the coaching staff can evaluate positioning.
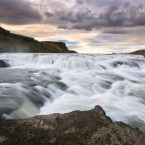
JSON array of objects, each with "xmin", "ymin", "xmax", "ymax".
[{"xmin": 0, "ymin": 54, "xmax": 145, "ymax": 132}]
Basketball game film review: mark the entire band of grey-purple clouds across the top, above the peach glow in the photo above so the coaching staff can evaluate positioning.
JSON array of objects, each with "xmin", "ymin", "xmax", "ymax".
[{"xmin": 0, "ymin": 0, "xmax": 145, "ymax": 31}]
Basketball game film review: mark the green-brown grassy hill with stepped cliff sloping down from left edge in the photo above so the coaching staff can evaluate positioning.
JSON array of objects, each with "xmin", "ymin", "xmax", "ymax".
[{"xmin": 0, "ymin": 27, "xmax": 76, "ymax": 53}]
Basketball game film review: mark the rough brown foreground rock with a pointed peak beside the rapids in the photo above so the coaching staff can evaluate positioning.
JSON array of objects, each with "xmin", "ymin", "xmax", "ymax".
[{"xmin": 0, "ymin": 106, "xmax": 145, "ymax": 145}]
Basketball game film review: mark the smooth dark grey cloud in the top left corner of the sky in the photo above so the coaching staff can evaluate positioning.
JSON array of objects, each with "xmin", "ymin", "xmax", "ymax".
[{"xmin": 0, "ymin": 0, "xmax": 42, "ymax": 24}]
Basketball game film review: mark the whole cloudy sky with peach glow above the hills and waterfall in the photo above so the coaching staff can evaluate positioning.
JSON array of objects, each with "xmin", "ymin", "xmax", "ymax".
[{"xmin": 0, "ymin": 0, "xmax": 145, "ymax": 53}]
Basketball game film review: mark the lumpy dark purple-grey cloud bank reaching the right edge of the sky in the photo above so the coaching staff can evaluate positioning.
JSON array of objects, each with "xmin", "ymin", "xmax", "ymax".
[{"xmin": 63, "ymin": 3, "xmax": 145, "ymax": 30}]
